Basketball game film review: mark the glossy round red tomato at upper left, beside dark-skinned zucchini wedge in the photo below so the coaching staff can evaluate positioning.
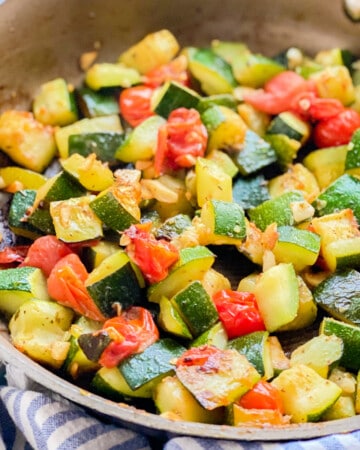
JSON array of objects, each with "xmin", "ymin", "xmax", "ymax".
[{"xmin": 119, "ymin": 85, "xmax": 154, "ymax": 127}]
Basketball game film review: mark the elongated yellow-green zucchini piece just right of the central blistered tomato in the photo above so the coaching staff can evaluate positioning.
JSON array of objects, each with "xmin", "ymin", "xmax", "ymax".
[{"xmin": 148, "ymin": 246, "xmax": 215, "ymax": 302}]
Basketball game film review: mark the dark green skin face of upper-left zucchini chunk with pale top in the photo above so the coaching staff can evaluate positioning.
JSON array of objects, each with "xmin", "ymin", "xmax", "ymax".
[{"xmin": 69, "ymin": 132, "xmax": 125, "ymax": 164}]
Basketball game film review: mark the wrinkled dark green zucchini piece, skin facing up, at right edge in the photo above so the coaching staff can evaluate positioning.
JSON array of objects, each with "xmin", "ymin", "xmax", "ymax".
[{"xmin": 313, "ymin": 269, "xmax": 360, "ymax": 326}]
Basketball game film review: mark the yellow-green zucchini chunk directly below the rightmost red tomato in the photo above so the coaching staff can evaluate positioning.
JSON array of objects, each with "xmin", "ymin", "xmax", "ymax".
[{"xmin": 303, "ymin": 145, "xmax": 348, "ymax": 189}]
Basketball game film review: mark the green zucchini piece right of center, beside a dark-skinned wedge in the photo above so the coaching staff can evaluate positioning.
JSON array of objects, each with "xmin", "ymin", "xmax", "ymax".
[{"xmin": 248, "ymin": 191, "xmax": 304, "ymax": 231}]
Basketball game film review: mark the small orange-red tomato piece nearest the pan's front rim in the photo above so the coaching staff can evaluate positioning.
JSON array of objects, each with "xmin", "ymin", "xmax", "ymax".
[{"xmin": 237, "ymin": 381, "xmax": 284, "ymax": 414}]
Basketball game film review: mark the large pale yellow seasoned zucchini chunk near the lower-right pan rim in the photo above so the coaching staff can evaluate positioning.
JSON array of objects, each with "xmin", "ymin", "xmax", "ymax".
[{"xmin": 271, "ymin": 364, "xmax": 341, "ymax": 423}]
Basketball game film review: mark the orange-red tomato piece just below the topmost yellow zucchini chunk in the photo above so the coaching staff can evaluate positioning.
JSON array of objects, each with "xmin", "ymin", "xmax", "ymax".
[{"xmin": 144, "ymin": 55, "xmax": 189, "ymax": 88}]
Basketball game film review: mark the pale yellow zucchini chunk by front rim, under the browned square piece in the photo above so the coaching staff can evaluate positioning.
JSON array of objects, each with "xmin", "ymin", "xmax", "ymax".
[{"xmin": 153, "ymin": 376, "xmax": 223, "ymax": 424}]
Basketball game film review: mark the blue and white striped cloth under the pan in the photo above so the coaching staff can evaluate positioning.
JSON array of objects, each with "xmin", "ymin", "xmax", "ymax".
[{"xmin": 0, "ymin": 371, "xmax": 360, "ymax": 450}]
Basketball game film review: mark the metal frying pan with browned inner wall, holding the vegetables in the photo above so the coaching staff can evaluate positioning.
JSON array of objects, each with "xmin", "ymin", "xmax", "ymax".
[{"xmin": 0, "ymin": 0, "xmax": 360, "ymax": 441}]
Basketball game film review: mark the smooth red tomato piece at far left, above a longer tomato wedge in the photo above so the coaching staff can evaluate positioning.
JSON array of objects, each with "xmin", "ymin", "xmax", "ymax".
[{"xmin": 21, "ymin": 235, "xmax": 72, "ymax": 277}]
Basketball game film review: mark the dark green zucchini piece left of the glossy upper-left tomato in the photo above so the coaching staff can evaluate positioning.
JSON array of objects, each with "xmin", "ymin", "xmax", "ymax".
[{"xmin": 77, "ymin": 87, "xmax": 119, "ymax": 119}]
